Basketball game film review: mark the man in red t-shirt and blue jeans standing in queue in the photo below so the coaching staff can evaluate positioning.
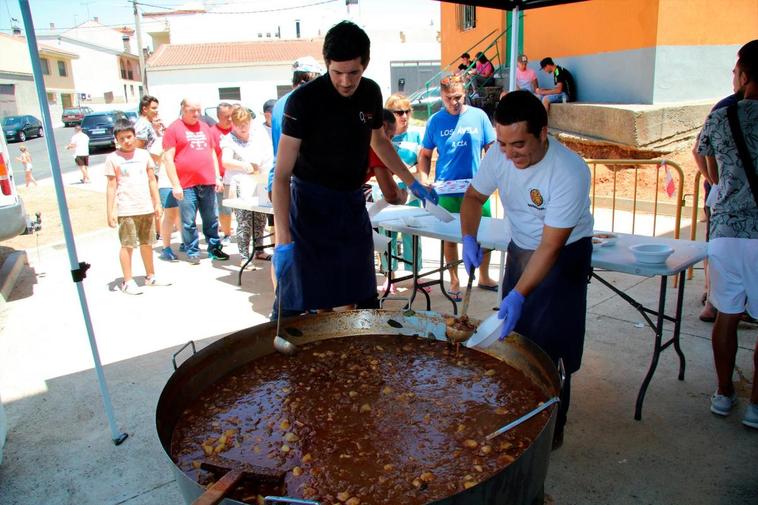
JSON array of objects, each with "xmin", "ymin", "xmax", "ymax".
[{"xmin": 163, "ymin": 98, "xmax": 229, "ymax": 264}]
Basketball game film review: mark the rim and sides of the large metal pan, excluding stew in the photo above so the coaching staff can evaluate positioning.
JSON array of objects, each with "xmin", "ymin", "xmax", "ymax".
[{"xmin": 155, "ymin": 310, "xmax": 560, "ymax": 505}]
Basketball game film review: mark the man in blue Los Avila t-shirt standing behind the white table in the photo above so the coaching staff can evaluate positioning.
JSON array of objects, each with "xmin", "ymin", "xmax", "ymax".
[{"xmin": 418, "ymin": 76, "xmax": 497, "ymax": 301}]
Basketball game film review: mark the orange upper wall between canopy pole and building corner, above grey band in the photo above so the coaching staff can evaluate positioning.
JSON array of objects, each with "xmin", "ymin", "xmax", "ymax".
[{"xmin": 524, "ymin": 0, "xmax": 665, "ymax": 61}]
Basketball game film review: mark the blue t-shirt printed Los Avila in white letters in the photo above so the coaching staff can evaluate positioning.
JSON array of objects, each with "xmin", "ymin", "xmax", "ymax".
[{"xmin": 422, "ymin": 106, "xmax": 495, "ymax": 181}]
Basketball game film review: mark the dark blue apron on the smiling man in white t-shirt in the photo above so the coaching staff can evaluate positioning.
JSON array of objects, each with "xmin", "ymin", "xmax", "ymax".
[{"xmin": 503, "ymin": 237, "xmax": 592, "ymax": 374}]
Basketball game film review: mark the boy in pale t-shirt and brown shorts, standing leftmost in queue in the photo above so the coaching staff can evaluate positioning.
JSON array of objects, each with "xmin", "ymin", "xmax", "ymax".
[{"xmin": 105, "ymin": 120, "xmax": 170, "ymax": 295}]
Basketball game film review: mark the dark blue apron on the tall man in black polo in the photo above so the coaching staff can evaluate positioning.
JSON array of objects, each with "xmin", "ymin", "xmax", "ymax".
[{"xmin": 281, "ymin": 177, "xmax": 377, "ymax": 310}]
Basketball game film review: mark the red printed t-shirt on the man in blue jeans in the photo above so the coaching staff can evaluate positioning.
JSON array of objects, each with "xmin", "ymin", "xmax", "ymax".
[{"xmin": 163, "ymin": 119, "xmax": 216, "ymax": 189}]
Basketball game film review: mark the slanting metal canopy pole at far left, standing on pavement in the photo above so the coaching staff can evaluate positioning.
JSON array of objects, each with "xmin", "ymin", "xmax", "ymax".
[{"xmin": 18, "ymin": 0, "xmax": 129, "ymax": 445}]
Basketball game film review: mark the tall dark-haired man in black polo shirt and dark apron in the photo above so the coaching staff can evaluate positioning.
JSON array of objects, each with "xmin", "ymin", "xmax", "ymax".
[{"xmin": 272, "ymin": 21, "xmax": 436, "ymax": 318}]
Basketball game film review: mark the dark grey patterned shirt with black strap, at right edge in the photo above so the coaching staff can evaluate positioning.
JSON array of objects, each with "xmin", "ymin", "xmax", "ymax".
[{"xmin": 697, "ymin": 100, "xmax": 758, "ymax": 239}]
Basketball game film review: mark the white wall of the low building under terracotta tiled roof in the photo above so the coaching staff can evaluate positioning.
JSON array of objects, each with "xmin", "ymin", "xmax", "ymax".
[{"xmin": 148, "ymin": 64, "xmax": 292, "ymax": 122}]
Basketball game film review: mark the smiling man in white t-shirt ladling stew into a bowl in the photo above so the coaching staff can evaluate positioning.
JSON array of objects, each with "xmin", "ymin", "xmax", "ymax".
[{"xmin": 461, "ymin": 90, "xmax": 593, "ymax": 449}]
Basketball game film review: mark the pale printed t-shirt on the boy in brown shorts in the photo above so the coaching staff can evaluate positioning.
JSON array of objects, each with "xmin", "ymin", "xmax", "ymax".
[{"xmin": 105, "ymin": 149, "xmax": 155, "ymax": 217}]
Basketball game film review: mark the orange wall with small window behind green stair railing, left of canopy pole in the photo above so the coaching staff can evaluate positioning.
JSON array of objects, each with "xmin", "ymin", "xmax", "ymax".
[{"xmin": 440, "ymin": 2, "xmax": 507, "ymax": 72}]
